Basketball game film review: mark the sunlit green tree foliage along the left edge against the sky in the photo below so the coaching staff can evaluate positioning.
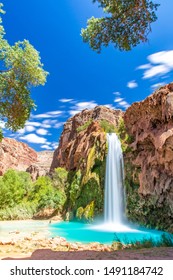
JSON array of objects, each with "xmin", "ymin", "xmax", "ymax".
[{"xmin": 0, "ymin": 3, "xmax": 48, "ymax": 138}]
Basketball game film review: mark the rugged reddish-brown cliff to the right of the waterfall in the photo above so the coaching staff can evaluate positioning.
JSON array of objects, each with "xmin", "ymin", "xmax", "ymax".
[{"xmin": 124, "ymin": 84, "xmax": 173, "ymax": 231}]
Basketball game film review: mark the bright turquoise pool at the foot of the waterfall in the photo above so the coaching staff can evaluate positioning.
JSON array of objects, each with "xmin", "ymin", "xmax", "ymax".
[{"xmin": 49, "ymin": 222, "xmax": 172, "ymax": 244}]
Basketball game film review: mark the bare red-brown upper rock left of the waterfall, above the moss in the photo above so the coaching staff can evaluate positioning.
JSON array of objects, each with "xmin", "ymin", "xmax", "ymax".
[{"xmin": 51, "ymin": 106, "xmax": 123, "ymax": 170}]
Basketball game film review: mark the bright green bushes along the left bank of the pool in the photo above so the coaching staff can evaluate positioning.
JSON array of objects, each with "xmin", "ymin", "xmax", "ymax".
[{"xmin": 0, "ymin": 169, "xmax": 66, "ymax": 220}]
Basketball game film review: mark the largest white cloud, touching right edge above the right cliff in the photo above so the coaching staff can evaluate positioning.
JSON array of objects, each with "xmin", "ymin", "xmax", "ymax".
[{"xmin": 137, "ymin": 50, "xmax": 173, "ymax": 79}]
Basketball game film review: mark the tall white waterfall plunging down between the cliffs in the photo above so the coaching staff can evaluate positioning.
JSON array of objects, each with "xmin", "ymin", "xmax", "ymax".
[{"xmin": 104, "ymin": 133, "xmax": 125, "ymax": 226}]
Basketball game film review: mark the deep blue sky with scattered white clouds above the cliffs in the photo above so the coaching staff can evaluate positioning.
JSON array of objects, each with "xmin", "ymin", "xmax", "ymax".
[{"xmin": 0, "ymin": 0, "xmax": 173, "ymax": 151}]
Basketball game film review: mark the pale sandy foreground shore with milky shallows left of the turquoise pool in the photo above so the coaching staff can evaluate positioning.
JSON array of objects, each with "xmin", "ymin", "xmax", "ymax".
[{"xmin": 0, "ymin": 220, "xmax": 173, "ymax": 260}]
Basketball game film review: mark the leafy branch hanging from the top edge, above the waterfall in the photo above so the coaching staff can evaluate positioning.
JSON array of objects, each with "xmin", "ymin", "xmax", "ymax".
[{"xmin": 81, "ymin": 0, "xmax": 159, "ymax": 52}]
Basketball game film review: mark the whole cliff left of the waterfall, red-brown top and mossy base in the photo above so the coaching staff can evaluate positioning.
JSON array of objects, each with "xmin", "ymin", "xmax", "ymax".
[{"xmin": 51, "ymin": 106, "xmax": 123, "ymax": 220}]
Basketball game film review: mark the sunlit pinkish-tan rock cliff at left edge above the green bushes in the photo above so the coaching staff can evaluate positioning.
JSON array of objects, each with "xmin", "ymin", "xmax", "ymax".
[{"xmin": 0, "ymin": 138, "xmax": 37, "ymax": 175}]
